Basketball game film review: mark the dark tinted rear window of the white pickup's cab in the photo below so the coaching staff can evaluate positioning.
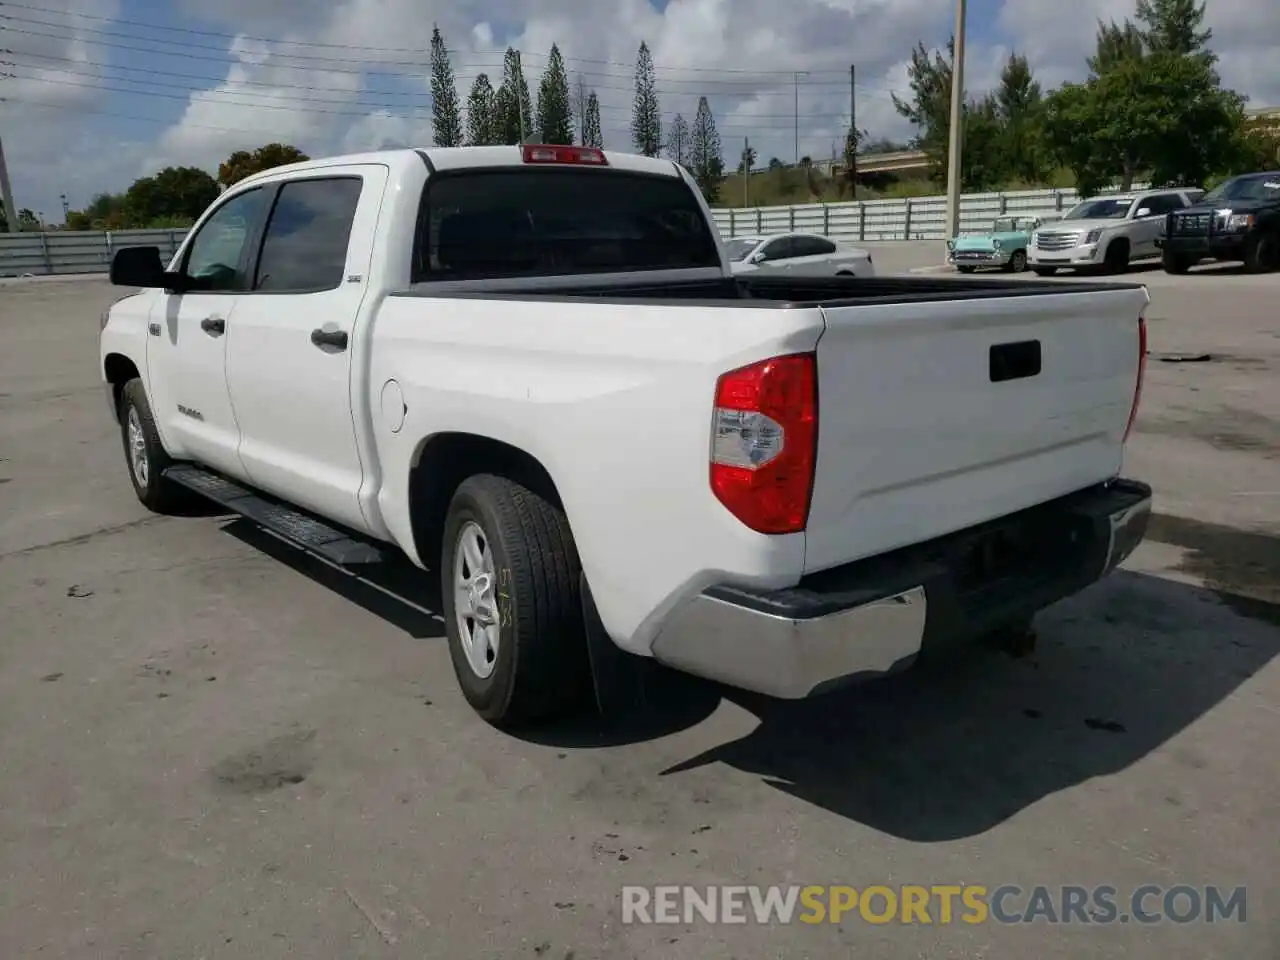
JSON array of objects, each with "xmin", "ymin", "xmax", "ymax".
[{"xmin": 413, "ymin": 166, "xmax": 721, "ymax": 282}]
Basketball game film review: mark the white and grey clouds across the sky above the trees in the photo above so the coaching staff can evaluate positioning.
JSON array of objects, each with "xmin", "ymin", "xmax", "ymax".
[{"xmin": 0, "ymin": 0, "xmax": 1280, "ymax": 216}]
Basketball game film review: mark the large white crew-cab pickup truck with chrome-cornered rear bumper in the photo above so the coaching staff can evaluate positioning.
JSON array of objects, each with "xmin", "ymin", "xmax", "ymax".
[{"xmin": 101, "ymin": 146, "xmax": 1151, "ymax": 724}]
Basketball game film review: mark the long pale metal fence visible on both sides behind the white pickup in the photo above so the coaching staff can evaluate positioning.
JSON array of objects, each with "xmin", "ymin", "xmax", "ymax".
[{"xmin": 0, "ymin": 187, "xmax": 1140, "ymax": 276}]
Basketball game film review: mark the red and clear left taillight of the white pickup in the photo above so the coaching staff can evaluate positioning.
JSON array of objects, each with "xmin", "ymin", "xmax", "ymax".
[{"xmin": 712, "ymin": 353, "xmax": 818, "ymax": 534}]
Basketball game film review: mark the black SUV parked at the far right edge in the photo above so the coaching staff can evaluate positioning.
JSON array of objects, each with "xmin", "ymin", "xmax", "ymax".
[{"xmin": 1157, "ymin": 170, "xmax": 1280, "ymax": 274}]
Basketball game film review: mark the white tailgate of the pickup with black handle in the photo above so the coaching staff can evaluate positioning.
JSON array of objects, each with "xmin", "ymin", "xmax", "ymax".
[{"xmin": 805, "ymin": 285, "xmax": 1149, "ymax": 572}]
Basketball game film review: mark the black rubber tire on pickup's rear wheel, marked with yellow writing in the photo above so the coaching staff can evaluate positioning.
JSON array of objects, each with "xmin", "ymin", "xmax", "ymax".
[{"xmin": 440, "ymin": 475, "xmax": 590, "ymax": 727}]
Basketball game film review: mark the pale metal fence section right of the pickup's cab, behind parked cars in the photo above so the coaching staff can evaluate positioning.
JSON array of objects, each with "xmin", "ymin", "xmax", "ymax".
[{"xmin": 714, "ymin": 186, "xmax": 1142, "ymax": 242}]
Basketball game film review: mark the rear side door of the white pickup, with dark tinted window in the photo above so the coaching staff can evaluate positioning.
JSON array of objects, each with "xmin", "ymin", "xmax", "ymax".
[{"xmin": 227, "ymin": 165, "xmax": 387, "ymax": 530}]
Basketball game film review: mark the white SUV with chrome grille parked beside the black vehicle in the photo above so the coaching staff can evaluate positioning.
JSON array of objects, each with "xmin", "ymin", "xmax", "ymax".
[{"xmin": 1027, "ymin": 189, "xmax": 1203, "ymax": 276}]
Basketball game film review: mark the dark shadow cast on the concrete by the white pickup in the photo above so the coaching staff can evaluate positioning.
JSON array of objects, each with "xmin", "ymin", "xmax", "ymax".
[{"xmin": 215, "ymin": 518, "xmax": 1280, "ymax": 842}]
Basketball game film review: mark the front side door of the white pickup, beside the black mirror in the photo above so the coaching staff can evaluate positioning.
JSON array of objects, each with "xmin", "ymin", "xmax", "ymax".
[{"xmin": 147, "ymin": 188, "xmax": 269, "ymax": 479}]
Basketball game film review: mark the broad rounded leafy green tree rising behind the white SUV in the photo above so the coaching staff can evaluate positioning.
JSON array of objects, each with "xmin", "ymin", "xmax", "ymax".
[{"xmin": 1044, "ymin": 52, "xmax": 1244, "ymax": 193}]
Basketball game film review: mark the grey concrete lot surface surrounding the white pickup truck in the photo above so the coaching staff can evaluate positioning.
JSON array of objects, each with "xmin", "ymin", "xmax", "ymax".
[{"xmin": 0, "ymin": 272, "xmax": 1280, "ymax": 960}]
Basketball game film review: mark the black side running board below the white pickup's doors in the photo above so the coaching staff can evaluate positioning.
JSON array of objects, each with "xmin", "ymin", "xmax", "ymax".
[{"xmin": 164, "ymin": 463, "xmax": 387, "ymax": 566}]
